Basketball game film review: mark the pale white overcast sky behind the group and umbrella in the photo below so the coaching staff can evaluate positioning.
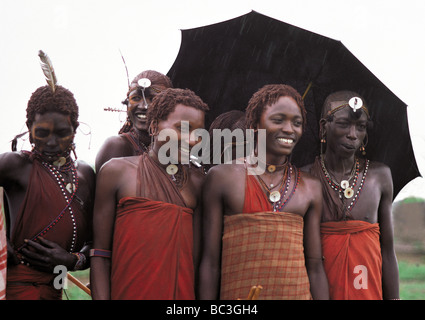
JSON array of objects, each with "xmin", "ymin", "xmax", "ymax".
[{"xmin": 0, "ymin": 0, "xmax": 425, "ymax": 200}]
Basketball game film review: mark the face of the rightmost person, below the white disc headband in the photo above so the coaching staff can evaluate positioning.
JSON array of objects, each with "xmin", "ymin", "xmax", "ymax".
[{"xmin": 324, "ymin": 101, "xmax": 368, "ymax": 158}]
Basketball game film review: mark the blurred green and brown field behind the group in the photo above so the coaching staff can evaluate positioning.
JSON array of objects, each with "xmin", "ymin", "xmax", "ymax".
[{"xmin": 63, "ymin": 198, "xmax": 425, "ymax": 300}]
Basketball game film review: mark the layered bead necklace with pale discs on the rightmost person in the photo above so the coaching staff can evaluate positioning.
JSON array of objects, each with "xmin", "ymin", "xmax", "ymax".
[{"xmin": 320, "ymin": 154, "xmax": 369, "ymax": 219}]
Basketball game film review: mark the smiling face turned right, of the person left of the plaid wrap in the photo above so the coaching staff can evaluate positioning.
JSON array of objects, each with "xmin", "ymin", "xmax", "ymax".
[{"xmin": 152, "ymin": 104, "xmax": 205, "ymax": 163}]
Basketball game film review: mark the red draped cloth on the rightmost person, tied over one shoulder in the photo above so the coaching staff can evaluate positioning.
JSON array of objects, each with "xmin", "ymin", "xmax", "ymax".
[{"xmin": 311, "ymin": 158, "xmax": 382, "ymax": 300}]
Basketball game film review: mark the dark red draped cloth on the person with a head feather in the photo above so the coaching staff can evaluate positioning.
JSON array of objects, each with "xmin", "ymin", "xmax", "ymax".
[{"xmin": 6, "ymin": 159, "xmax": 90, "ymax": 300}]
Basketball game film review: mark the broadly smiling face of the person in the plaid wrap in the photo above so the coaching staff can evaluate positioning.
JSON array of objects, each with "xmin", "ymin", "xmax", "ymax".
[{"xmin": 258, "ymin": 96, "xmax": 303, "ymax": 156}]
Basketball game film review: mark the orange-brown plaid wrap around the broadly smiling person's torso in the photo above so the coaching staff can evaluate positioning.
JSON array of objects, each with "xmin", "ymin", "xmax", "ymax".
[{"xmin": 220, "ymin": 212, "xmax": 311, "ymax": 300}]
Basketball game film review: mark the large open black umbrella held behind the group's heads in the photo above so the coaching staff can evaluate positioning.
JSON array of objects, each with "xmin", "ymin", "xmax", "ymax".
[{"xmin": 168, "ymin": 11, "xmax": 420, "ymax": 197}]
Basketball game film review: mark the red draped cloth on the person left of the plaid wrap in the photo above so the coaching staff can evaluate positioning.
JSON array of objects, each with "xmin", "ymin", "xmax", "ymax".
[{"xmin": 111, "ymin": 153, "xmax": 195, "ymax": 300}]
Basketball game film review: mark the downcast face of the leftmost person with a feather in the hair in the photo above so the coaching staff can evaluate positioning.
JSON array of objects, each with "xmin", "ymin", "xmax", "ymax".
[{"xmin": 31, "ymin": 112, "xmax": 75, "ymax": 162}]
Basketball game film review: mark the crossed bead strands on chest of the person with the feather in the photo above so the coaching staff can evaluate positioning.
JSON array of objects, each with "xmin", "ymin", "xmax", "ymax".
[{"xmin": 27, "ymin": 154, "xmax": 78, "ymax": 253}]
